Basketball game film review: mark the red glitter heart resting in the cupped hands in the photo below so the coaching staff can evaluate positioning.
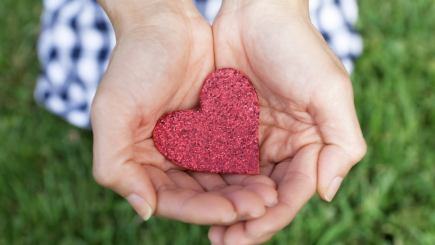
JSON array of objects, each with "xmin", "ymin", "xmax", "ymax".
[{"xmin": 153, "ymin": 68, "xmax": 260, "ymax": 174}]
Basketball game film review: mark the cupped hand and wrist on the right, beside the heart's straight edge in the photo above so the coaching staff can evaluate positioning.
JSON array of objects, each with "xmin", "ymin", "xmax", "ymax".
[{"xmin": 209, "ymin": 0, "xmax": 366, "ymax": 245}]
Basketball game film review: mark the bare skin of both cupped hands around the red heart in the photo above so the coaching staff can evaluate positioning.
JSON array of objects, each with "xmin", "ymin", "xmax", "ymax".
[{"xmin": 91, "ymin": 0, "xmax": 366, "ymax": 245}]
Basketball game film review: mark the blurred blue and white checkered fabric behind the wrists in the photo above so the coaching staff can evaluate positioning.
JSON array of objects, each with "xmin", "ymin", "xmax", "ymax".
[{"xmin": 35, "ymin": 0, "xmax": 363, "ymax": 128}]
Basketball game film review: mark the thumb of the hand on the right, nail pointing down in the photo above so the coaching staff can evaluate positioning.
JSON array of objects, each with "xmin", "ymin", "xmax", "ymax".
[{"xmin": 310, "ymin": 76, "xmax": 367, "ymax": 201}]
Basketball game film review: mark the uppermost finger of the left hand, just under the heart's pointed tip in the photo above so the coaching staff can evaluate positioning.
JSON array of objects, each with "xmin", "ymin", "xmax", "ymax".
[{"xmin": 222, "ymin": 174, "xmax": 278, "ymax": 207}]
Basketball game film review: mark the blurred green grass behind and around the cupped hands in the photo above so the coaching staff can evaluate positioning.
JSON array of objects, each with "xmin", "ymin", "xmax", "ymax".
[{"xmin": 0, "ymin": 0, "xmax": 435, "ymax": 245}]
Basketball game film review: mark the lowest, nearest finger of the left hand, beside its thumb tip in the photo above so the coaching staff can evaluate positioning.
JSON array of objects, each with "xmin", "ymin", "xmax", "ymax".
[{"xmin": 143, "ymin": 165, "xmax": 237, "ymax": 225}]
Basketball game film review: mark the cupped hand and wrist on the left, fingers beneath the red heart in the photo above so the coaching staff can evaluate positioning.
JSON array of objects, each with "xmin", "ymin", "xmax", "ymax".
[{"xmin": 91, "ymin": 0, "xmax": 277, "ymax": 224}]
